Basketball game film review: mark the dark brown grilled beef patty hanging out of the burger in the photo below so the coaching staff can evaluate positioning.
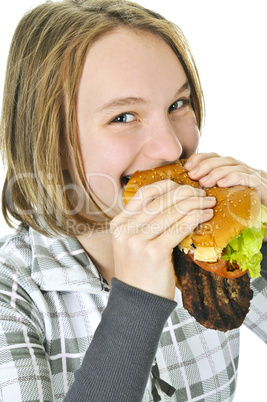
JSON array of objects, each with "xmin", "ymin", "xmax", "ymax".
[{"xmin": 173, "ymin": 247, "xmax": 253, "ymax": 332}]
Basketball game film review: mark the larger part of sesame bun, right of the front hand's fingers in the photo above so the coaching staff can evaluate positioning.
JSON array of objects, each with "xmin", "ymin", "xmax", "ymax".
[{"xmin": 183, "ymin": 186, "xmax": 261, "ymax": 262}]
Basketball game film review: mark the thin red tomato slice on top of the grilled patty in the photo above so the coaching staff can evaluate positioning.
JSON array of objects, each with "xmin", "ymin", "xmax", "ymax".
[{"xmin": 188, "ymin": 253, "xmax": 248, "ymax": 278}]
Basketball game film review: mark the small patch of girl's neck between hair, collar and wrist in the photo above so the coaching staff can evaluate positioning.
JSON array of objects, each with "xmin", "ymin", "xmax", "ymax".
[{"xmin": 77, "ymin": 230, "xmax": 114, "ymax": 284}]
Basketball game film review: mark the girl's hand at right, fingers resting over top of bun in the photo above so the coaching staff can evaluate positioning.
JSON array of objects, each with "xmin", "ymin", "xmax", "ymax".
[{"xmin": 185, "ymin": 153, "xmax": 267, "ymax": 206}]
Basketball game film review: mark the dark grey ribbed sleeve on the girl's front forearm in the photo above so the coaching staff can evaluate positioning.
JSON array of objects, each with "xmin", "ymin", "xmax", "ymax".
[{"xmin": 64, "ymin": 278, "xmax": 176, "ymax": 402}]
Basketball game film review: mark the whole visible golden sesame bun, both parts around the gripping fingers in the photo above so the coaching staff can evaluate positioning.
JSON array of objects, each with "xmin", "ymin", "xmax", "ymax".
[{"xmin": 124, "ymin": 160, "xmax": 261, "ymax": 262}]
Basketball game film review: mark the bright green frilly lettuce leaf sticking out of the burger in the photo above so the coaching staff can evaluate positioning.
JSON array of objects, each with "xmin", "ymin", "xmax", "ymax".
[{"xmin": 222, "ymin": 227, "xmax": 265, "ymax": 278}]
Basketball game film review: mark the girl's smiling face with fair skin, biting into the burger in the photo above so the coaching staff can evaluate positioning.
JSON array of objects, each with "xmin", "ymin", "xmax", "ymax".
[{"xmin": 77, "ymin": 28, "xmax": 199, "ymax": 217}]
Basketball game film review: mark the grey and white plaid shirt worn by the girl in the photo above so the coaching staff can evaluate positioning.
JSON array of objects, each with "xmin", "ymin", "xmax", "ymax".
[{"xmin": 0, "ymin": 228, "xmax": 267, "ymax": 402}]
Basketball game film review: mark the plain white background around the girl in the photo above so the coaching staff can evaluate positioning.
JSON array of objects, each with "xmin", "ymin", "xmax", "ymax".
[{"xmin": 0, "ymin": 0, "xmax": 267, "ymax": 402}]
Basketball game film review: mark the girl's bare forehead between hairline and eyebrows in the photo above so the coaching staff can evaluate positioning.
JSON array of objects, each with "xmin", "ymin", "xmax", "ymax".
[{"xmin": 79, "ymin": 28, "xmax": 186, "ymax": 106}]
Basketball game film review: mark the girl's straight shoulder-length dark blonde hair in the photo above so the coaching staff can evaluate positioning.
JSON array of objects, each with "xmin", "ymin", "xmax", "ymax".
[{"xmin": 1, "ymin": 0, "xmax": 204, "ymax": 236}]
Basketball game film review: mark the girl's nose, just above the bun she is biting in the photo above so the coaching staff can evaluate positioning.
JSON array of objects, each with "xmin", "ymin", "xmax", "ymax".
[{"xmin": 143, "ymin": 119, "xmax": 183, "ymax": 165}]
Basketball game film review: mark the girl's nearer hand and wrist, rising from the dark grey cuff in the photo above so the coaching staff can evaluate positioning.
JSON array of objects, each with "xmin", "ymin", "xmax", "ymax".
[{"xmin": 111, "ymin": 180, "xmax": 216, "ymax": 299}]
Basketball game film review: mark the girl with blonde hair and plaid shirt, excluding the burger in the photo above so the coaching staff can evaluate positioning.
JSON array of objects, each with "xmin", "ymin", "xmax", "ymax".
[{"xmin": 0, "ymin": 0, "xmax": 267, "ymax": 402}]
